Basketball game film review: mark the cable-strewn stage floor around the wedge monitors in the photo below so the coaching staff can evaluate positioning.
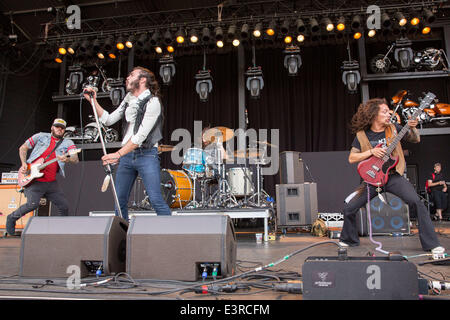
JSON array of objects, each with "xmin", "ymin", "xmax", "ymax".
[{"xmin": 0, "ymin": 221, "xmax": 450, "ymax": 303}]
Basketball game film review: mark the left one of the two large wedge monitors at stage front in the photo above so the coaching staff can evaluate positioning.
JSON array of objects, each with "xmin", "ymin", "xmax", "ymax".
[{"xmin": 19, "ymin": 216, "xmax": 128, "ymax": 279}]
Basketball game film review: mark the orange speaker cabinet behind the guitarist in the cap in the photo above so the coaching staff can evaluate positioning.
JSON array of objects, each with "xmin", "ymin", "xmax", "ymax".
[{"xmin": 0, "ymin": 184, "xmax": 33, "ymax": 230}]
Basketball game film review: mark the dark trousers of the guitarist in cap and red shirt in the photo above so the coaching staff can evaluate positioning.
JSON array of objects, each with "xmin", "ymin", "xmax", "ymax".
[{"xmin": 6, "ymin": 181, "xmax": 69, "ymax": 234}]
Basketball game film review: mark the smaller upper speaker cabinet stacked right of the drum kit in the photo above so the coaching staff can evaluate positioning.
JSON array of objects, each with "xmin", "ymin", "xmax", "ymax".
[{"xmin": 280, "ymin": 151, "xmax": 305, "ymax": 184}]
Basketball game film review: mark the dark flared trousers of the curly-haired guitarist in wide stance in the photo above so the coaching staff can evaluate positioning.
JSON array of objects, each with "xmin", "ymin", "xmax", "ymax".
[{"xmin": 340, "ymin": 173, "xmax": 440, "ymax": 251}]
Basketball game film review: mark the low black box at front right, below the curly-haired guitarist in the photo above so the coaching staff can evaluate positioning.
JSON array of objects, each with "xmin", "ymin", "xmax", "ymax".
[{"xmin": 302, "ymin": 257, "xmax": 419, "ymax": 300}]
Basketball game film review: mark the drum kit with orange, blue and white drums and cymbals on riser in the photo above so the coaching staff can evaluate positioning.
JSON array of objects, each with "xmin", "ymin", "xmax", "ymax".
[{"xmin": 134, "ymin": 127, "xmax": 273, "ymax": 209}]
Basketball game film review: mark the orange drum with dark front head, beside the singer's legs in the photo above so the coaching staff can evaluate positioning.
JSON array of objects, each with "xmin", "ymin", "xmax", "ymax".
[{"xmin": 161, "ymin": 169, "xmax": 193, "ymax": 208}]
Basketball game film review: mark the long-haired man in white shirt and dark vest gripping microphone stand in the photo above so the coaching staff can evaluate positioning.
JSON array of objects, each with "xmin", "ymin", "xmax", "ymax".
[{"xmin": 84, "ymin": 67, "xmax": 171, "ymax": 220}]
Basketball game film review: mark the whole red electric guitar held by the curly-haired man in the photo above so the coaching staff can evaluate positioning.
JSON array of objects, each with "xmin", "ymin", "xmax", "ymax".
[{"xmin": 358, "ymin": 92, "xmax": 436, "ymax": 187}]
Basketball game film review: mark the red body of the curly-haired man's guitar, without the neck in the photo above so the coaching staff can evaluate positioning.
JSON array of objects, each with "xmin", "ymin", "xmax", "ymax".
[{"xmin": 358, "ymin": 149, "xmax": 398, "ymax": 187}]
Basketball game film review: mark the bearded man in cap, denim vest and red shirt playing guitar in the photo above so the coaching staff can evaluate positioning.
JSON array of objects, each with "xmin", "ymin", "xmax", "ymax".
[{"xmin": 6, "ymin": 119, "xmax": 78, "ymax": 236}]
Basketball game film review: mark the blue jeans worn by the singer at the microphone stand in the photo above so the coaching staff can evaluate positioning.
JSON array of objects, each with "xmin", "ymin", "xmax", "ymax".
[{"xmin": 115, "ymin": 147, "xmax": 172, "ymax": 220}]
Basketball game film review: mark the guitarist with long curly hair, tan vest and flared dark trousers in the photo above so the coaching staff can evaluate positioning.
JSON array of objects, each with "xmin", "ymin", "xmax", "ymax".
[{"xmin": 340, "ymin": 98, "xmax": 445, "ymax": 253}]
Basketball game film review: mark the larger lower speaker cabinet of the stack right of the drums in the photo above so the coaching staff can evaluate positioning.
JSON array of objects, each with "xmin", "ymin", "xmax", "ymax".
[{"xmin": 276, "ymin": 182, "xmax": 318, "ymax": 227}]
